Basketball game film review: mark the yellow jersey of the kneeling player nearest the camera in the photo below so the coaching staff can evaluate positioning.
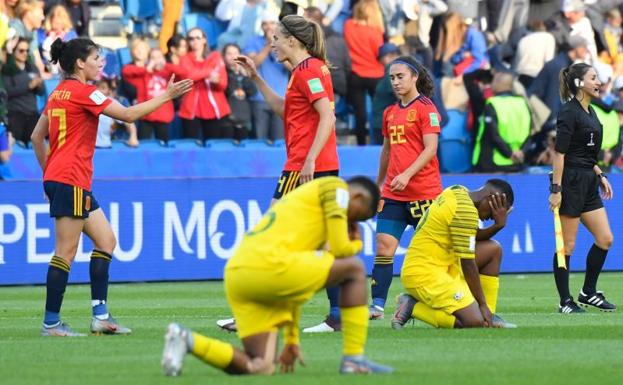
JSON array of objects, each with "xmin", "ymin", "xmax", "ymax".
[{"xmin": 227, "ymin": 176, "xmax": 361, "ymax": 269}]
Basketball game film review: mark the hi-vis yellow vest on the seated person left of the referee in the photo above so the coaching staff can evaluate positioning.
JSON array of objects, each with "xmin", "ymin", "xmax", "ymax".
[{"xmin": 472, "ymin": 95, "xmax": 531, "ymax": 166}]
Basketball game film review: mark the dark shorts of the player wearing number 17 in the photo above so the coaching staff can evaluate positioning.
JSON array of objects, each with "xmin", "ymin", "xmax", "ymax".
[{"xmin": 43, "ymin": 181, "xmax": 100, "ymax": 219}]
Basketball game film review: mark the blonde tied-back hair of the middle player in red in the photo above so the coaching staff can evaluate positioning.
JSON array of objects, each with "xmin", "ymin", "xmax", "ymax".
[{"xmin": 280, "ymin": 15, "xmax": 330, "ymax": 65}]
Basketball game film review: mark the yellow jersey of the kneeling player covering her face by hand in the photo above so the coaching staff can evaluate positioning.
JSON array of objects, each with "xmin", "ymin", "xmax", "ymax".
[{"xmin": 402, "ymin": 185, "xmax": 478, "ymax": 276}]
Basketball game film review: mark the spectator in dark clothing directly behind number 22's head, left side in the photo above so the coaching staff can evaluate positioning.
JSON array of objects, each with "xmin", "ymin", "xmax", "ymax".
[{"xmin": 370, "ymin": 43, "xmax": 400, "ymax": 144}]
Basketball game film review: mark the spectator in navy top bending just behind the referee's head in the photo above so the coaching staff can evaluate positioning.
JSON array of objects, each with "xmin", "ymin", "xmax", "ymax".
[{"xmin": 528, "ymin": 36, "xmax": 588, "ymax": 131}]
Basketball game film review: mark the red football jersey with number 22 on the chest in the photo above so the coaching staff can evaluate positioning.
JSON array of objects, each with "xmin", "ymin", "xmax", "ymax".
[{"xmin": 383, "ymin": 95, "xmax": 442, "ymax": 201}]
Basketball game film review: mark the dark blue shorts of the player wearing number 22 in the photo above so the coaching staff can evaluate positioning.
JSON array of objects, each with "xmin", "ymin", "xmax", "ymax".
[{"xmin": 376, "ymin": 198, "xmax": 433, "ymax": 240}]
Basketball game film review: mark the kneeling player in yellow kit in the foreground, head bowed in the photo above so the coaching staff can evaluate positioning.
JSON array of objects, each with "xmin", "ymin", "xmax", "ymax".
[{"xmin": 162, "ymin": 176, "xmax": 393, "ymax": 376}]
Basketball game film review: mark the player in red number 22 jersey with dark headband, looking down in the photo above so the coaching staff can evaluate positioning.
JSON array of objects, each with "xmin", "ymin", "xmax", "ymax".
[{"xmin": 370, "ymin": 56, "xmax": 442, "ymax": 319}]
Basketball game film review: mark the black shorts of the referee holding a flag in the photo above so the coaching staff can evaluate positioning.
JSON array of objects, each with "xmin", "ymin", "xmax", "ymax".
[{"xmin": 559, "ymin": 168, "xmax": 604, "ymax": 218}]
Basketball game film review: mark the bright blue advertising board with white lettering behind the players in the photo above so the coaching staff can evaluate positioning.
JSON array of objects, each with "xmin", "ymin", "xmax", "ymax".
[{"xmin": 0, "ymin": 174, "xmax": 623, "ymax": 285}]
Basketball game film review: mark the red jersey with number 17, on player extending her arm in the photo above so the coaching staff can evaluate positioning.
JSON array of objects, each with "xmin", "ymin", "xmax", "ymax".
[{"xmin": 43, "ymin": 79, "xmax": 112, "ymax": 191}]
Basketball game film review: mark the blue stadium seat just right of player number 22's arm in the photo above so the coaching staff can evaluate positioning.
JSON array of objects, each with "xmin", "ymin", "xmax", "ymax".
[{"xmin": 437, "ymin": 110, "xmax": 473, "ymax": 173}]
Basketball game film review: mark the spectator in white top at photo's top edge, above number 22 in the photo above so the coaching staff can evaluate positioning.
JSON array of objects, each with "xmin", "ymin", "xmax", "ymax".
[{"xmin": 403, "ymin": 0, "xmax": 448, "ymax": 70}]
